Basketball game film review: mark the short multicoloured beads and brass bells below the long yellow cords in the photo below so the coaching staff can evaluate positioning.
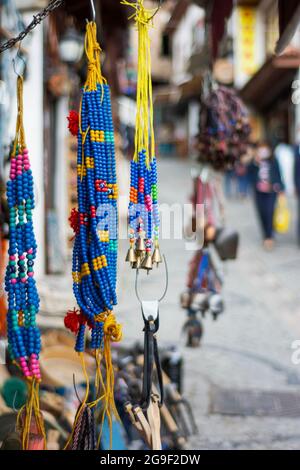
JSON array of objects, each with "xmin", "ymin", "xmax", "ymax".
[{"xmin": 126, "ymin": 150, "xmax": 162, "ymax": 273}]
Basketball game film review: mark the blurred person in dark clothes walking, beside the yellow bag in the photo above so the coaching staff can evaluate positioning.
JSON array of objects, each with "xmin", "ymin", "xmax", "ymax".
[{"xmin": 250, "ymin": 142, "xmax": 284, "ymax": 250}]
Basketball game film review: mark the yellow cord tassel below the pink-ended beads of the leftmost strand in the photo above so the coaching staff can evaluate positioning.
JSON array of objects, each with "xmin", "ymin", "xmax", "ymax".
[{"xmin": 17, "ymin": 380, "xmax": 46, "ymax": 450}]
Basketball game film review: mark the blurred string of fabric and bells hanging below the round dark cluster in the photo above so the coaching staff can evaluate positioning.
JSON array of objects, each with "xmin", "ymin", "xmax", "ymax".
[{"xmin": 181, "ymin": 171, "xmax": 223, "ymax": 347}]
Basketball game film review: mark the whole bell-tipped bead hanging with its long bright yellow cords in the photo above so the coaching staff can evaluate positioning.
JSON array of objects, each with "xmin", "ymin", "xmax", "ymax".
[{"xmin": 121, "ymin": 0, "xmax": 162, "ymax": 272}]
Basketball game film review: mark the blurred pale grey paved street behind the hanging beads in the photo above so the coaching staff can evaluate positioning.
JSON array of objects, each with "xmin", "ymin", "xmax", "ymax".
[{"xmin": 40, "ymin": 160, "xmax": 300, "ymax": 449}]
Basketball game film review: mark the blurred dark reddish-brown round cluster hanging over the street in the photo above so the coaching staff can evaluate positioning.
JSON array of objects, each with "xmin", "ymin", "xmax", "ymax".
[{"xmin": 198, "ymin": 86, "xmax": 250, "ymax": 171}]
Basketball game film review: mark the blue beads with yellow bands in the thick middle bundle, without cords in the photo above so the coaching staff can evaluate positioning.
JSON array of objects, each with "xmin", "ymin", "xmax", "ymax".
[{"xmin": 72, "ymin": 84, "xmax": 118, "ymax": 352}]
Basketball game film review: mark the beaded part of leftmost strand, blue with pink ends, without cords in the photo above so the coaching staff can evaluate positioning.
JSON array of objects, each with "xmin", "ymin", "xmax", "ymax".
[{"xmin": 5, "ymin": 147, "xmax": 41, "ymax": 382}]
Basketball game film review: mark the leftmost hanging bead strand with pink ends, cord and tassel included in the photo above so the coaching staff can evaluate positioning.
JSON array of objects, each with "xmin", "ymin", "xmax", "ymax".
[{"xmin": 5, "ymin": 76, "xmax": 46, "ymax": 450}]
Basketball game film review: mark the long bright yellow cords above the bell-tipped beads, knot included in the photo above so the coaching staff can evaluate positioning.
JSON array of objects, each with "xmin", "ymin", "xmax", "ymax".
[{"xmin": 121, "ymin": 0, "xmax": 155, "ymax": 167}]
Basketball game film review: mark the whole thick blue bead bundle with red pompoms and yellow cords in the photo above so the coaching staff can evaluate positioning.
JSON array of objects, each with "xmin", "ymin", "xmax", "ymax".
[{"xmin": 65, "ymin": 22, "xmax": 122, "ymax": 449}]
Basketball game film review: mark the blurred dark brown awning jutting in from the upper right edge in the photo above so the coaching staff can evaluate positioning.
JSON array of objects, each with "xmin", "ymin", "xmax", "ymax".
[{"xmin": 240, "ymin": 50, "xmax": 300, "ymax": 111}]
